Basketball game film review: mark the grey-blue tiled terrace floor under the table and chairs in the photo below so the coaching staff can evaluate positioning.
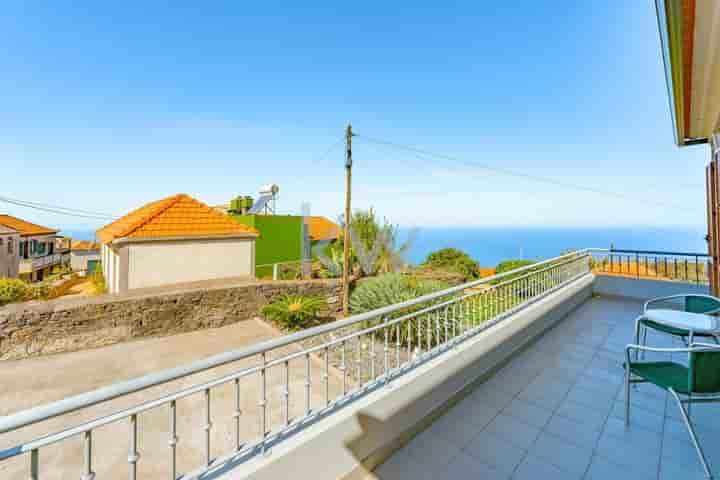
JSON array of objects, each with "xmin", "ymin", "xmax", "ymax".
[{"xmin": 374, "ymin": 298, "xmax": 720, "ymax": 480}]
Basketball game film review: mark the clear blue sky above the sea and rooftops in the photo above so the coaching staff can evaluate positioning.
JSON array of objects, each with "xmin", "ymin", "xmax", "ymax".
[{"xmin": 0, "ymin": 0, "xmax": 708, "ymax": 228}]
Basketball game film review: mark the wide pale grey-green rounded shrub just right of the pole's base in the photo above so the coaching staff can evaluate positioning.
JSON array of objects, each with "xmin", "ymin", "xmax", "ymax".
[{"xmin": 350, "ymin": 273, "xmax": 448, "ymax": 313}]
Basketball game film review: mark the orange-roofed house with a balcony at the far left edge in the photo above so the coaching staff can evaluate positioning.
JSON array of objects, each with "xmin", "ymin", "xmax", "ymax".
[{"xmin": 0, "ymin": 215, "xmax": 70, "ymax": 282}]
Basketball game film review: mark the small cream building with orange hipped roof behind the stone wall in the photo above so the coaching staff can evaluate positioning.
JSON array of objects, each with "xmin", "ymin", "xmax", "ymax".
[{"xmin": 97, "ymin": 193, "xmax": 258, "ymax": 293}]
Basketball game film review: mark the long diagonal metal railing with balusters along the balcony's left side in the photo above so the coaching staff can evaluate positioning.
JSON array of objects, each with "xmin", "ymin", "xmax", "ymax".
[{"xmin": 0, "ymin": 250, "xmax": 591, "ymax": 480}]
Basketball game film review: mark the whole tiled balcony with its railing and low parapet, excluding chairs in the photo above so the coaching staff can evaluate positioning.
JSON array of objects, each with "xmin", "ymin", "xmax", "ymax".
[{"xmin": 0, "ymin": 250, "xmax": 720, "ymax": 480}]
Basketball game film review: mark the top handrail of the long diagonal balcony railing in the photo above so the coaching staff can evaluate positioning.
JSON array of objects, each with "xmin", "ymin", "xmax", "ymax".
[{"xmin": 0, "ymin": 249, "xmax": 592, "ymax": 434}]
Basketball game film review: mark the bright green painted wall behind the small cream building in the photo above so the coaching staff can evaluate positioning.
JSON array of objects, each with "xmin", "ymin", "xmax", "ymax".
[{"xmin": 230, "ymin": 214, "xmax": 303, "ymax": 277}]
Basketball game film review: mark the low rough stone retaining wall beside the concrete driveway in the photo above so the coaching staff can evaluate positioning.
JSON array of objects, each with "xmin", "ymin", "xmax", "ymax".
[{"xmin": 0, "ymin": 279, "xmax": 342, "ymax": 360}]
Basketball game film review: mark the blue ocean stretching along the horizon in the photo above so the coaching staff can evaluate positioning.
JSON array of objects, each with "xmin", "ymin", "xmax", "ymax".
[{"xmin": 62, "ymin": 226, "xmax": 707, "ymax": 267}]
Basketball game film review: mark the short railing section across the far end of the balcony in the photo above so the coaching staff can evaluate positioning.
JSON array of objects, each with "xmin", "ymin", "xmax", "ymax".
[{"xmin": 593, "ymin": 249, "xmax": 712, "ymax": 283}]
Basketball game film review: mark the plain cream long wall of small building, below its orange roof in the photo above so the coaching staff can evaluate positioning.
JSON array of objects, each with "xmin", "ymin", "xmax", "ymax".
[{"xmin": 126, "ymin": 238, "xmax": 255, "ymax": 291}]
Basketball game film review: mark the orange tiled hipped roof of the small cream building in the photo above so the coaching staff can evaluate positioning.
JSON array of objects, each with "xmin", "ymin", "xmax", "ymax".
[{"xmin": 96, "ymin": 193, "xmax": 258, "ymax": 243}]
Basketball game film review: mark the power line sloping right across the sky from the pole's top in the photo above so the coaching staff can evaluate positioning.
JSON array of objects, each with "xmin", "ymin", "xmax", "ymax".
[{"xmin": 355, "ymin": 134, "xmax": 695, "ymax": 212}]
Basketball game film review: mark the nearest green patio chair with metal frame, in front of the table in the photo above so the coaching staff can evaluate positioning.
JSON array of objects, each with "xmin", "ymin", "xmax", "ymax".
[{"xmin": 624, "ymin": 343, "xmax": 720, "ymax": 478}]
